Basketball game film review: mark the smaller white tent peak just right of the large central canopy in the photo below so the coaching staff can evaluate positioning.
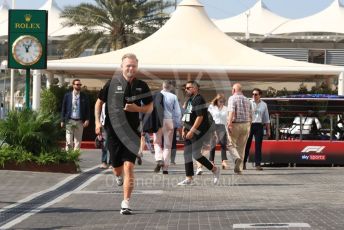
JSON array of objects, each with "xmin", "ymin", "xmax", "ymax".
[{"xmin": 213, "ymin": 0, "xmax": 289, "ymax": 35}]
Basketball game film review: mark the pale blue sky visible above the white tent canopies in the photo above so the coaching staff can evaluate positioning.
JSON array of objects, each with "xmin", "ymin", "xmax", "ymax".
[{"xmin": 0, "ymin": 0, "xmax": 344, "ymax": 19}]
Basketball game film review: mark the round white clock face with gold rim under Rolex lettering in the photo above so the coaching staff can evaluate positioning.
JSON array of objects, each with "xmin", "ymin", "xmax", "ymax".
[{"xmin": 12, "ymin": 35, "xmax": 42, "ymax": 66}]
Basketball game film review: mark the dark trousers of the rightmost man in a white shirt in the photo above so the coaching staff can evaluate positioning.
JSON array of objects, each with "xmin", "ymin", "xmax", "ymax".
[{"xmin": 244, "ymin": 123, "xmax": 264, "ymax": 166}]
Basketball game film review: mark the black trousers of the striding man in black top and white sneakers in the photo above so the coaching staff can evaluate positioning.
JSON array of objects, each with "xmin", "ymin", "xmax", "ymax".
[{"xmin": 184, "ymin": 138, "xmax": 214, "ymax": 176}]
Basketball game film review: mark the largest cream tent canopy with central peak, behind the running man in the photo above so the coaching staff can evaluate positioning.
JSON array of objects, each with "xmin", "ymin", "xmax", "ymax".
[{"xmin": 48, "ymin": 0, "xmax": 340, "ymax": 81}]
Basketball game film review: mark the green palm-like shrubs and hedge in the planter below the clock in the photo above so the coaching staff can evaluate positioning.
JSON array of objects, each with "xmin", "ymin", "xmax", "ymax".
[{"xmin": 0, "ymin": 110, "xmax": 80, "ymax": 167}]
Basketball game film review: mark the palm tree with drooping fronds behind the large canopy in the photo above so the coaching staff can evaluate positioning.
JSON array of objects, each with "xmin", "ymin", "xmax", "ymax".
[{"xmin": 61, "ymin": 0, "xmax": 173, "ymax": 57}]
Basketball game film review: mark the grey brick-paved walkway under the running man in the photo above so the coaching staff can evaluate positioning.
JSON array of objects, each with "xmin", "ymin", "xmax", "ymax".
[{"xmin": 0, "ymin": 150, "xmax": 344, "ymax": 230}]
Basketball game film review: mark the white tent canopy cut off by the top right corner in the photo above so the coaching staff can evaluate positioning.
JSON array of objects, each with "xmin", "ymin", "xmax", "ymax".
[{"xmin": 272, "ymin": 0, "xmax": 344, "ymax": 34}]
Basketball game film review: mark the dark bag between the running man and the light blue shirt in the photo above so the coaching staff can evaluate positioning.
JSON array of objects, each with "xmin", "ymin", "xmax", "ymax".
[{"xmin": 142, "ymin": 92, "xmax": 164, "ymax": 133}]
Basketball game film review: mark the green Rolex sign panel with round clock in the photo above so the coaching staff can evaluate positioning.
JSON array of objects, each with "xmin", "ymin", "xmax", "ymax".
[{"xmin": 8, "ymin": 10, "xmax": 48, "ymax": 69}]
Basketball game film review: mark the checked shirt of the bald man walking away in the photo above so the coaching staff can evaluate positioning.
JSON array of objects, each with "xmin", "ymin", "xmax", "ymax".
[{"xmin": 228, "ymin": 94, "xmax": 252, "ymax": 123}]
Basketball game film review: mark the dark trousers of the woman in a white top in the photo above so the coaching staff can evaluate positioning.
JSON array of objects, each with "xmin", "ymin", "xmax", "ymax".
[{"xmin": 209, "ymin": 125, "xmax": 227, "ymax": 161}]
